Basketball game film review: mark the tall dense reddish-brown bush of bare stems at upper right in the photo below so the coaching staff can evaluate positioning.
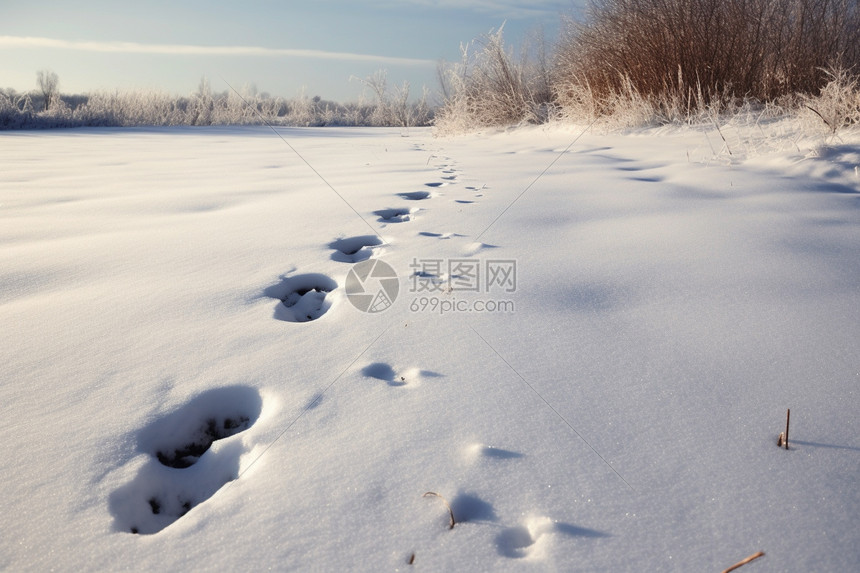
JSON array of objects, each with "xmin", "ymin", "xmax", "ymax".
[{"xmin": 555, "ymin": 0, "xmax": 860, "ymax": 121}]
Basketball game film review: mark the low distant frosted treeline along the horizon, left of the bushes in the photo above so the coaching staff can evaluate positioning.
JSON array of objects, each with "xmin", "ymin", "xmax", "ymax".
[{"xmin": 0, "ymin": 71, "xmax": 433, "ymax": 129}]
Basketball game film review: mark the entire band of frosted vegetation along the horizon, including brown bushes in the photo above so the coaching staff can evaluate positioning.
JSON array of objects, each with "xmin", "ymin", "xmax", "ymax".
[{"xmin": 6, "ymin": 0, "xmax": 860, "ymax": 134}]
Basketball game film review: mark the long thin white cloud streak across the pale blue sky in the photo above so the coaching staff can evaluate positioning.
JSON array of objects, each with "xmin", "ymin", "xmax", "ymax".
[{"xmin": 0, "ymin": 36, "xmax": 436, "ymax": 66}]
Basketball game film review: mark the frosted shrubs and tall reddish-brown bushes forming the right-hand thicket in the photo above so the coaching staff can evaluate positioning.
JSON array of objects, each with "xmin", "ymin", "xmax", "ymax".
[{"xmin": 436, "ymin": 0, "xmax": 860, "ymax": 133}]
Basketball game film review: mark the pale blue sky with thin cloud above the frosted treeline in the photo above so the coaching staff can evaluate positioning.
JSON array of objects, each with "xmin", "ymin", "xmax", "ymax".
[{"xmin": 0, "ymin": 0, "xmax": 582, "ymax": 102}]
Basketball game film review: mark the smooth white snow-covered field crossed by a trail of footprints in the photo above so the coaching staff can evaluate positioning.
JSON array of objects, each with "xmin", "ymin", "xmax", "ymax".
[{"xmin": 0, "ymin": 123, "xmax": 860, "ymax": 572}]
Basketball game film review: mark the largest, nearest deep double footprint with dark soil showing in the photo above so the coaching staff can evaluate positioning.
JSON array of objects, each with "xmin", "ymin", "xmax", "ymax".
[{"xmin": 108, "ymin": 386, "xmax": 263, "ymax": 534}]
